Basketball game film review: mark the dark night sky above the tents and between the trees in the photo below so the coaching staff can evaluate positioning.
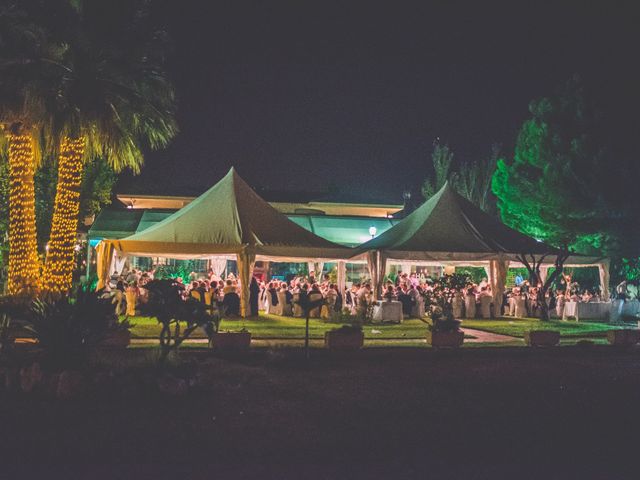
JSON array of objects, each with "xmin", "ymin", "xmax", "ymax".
[{"xmin": 117, "ymin": 0, "xmax": 640, "ymax": 203}]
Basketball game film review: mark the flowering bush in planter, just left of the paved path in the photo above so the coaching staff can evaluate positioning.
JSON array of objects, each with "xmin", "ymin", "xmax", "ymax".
[{"xmin": 423, "ymin": 274, "xmax": 467, "ymax": 348}]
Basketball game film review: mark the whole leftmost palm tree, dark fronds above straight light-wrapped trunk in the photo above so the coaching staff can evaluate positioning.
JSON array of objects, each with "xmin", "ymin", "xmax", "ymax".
[{"xmin": 0, "ymin": 5, "xmax": 55, "ymax": 294}]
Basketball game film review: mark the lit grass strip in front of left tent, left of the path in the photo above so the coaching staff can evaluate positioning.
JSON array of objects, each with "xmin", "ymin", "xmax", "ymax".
[{"xmin": 130, "ymin": 314, "xmax": 427, "ymax": 340}]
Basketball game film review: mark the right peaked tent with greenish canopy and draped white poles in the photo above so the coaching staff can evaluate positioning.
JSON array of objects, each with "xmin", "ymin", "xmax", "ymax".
[{"xmin": 354, "ymin": 183, "xmax": 609, "ymax": 302}]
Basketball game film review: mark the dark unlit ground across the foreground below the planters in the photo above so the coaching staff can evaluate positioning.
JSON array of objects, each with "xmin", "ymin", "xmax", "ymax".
[{"xmin": 0, "ymin": 347, "xmax": 640, "ymax": 479}]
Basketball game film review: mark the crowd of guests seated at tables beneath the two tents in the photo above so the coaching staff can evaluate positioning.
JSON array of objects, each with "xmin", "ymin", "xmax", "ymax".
[{"xmin": 106, "ymin": 267, "xmax": 600, "ymax": 320}]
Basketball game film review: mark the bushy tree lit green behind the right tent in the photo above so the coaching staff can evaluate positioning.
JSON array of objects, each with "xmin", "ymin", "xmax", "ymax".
[{"xmin": 492, "ymin": 78, "xmax": 612, "ymax": 251}]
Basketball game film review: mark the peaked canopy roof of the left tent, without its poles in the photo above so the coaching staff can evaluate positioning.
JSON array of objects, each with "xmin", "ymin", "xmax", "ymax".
[{"xmin": 107, "ymin": 168, "xmax": 351, "ymax": 259}]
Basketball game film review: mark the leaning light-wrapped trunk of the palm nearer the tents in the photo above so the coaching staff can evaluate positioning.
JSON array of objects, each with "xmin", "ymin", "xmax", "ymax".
[{"xmin": 44, "ymin": 137, "xmax": 85, "ymax": 295}]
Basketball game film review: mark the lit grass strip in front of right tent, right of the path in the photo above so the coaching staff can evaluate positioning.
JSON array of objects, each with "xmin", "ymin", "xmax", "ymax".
[{"xmin": 462, "ymin": 318, "xmax": 636, "ymax": 338}]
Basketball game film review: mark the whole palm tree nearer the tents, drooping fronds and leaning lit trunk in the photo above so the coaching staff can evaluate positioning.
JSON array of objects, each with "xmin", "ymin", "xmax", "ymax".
[{"xmin": 43, "ymin": 0, "xmax": 177, "ymax": 294}]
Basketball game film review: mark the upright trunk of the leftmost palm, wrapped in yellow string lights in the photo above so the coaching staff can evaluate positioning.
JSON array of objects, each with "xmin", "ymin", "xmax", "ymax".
[{"xmin": 7, "ymin": 133, "xmax": 40, "ymax": 295}]
